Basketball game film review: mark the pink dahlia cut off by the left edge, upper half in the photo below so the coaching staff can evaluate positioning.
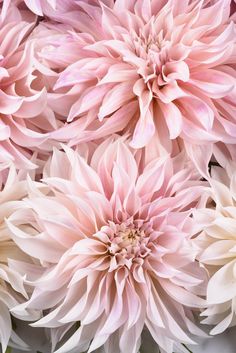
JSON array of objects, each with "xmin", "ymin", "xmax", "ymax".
[{"xmin": 0, "ymin": 4, "xmax": 50, "ymax": 169}]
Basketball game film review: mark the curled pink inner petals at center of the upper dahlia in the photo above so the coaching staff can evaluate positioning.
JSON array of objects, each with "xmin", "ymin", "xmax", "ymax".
[{"xmin": 124, "ymin": 19, "xmax": 190, "ymax": 92}]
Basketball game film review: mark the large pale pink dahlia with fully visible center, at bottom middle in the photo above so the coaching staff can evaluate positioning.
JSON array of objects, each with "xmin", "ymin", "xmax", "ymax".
[{"xmin": 7, "ymin": 137, "xmax": 207, "ymax": 353}]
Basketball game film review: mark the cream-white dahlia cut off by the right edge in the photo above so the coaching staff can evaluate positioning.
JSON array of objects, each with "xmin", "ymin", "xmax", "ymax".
[{"xmin": 194, "ymin": 164, "xmax": 236, "ymax": 334}]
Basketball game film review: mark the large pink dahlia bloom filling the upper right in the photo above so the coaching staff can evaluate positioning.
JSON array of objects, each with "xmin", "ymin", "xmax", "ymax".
[{"xmin": 45, "ymin": 0, "xmax": 236, "ymax": 154}]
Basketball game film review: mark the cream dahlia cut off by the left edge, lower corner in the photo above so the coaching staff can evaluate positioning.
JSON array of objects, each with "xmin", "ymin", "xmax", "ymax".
[{"xmin": 0, "ymin": 167, "xmax": 36, "ymax": 353}]
